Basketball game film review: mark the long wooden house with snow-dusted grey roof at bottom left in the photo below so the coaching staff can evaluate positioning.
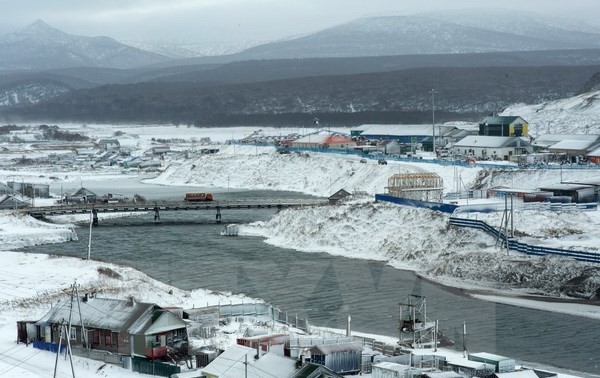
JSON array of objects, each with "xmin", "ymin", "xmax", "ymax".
[{"xmin": 28, "ymin": 296, "xmax": 187, "ymax": 359}]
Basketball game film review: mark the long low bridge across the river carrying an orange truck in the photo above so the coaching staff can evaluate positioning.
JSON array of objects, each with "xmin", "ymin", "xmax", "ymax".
[{"xmin": 21, "ymin": 199, "xmax": 328, "ymax": 225}]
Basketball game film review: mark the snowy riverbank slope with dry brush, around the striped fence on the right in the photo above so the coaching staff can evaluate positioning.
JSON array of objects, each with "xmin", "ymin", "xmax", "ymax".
[{"xmin": 242, "ymin": 201, "xmax": 600, "ymax": 298}]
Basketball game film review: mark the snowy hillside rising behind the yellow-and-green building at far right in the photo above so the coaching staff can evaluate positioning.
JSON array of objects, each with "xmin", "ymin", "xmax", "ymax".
[{"xmin": 501, "ymin": 91, "xmax": 600, "ymax": 137}]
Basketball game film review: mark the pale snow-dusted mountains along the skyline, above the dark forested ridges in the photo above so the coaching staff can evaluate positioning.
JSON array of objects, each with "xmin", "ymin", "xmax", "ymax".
[{"xmin": 0, "ymin": 9, "xmax": 600, "ymax": 70}]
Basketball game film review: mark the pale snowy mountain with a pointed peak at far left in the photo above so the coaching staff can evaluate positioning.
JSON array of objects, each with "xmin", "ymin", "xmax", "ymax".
[{"xmin": 0, "ymin": 20, "xmax": 169, "ymax": 70}]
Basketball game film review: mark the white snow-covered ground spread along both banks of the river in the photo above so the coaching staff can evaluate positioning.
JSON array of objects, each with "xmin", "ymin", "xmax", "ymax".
[{"xmin": 0, "ymin": 125, "xmax": 600, "ymax": 377}]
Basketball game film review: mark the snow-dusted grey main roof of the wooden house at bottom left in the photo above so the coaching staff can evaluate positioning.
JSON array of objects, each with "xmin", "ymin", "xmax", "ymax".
[{"xmin": 38, "ymin": 298, "xmax": 155, "ymax": 332}]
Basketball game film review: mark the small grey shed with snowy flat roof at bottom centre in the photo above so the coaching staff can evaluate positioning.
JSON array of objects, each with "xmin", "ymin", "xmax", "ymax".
[{"xmin": 310, "ymin": 342, "xmax": 363, "ymax": 374}]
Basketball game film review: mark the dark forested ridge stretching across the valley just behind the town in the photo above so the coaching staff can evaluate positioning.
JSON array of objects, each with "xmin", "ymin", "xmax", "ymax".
[{"xmin": 0, "ymin": 66, "xmax": 600, "ymax": 125}]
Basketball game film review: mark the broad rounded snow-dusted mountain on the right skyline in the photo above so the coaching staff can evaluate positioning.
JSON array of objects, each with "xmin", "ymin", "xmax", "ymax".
[{"xmin": 233, "ymin": 12, "xmax": 600, "ymax": 59}]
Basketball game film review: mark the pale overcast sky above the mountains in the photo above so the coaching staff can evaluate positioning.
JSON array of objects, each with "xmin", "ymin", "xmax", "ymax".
[{"xmin": 0, "ymin": 0, "xmax": 600, "ymax": 42}]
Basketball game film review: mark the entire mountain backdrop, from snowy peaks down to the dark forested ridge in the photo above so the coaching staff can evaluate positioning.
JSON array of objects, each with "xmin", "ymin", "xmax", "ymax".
[{"xmin": 0, "ymin": 10, "xmax": 600, "ymax": 125}]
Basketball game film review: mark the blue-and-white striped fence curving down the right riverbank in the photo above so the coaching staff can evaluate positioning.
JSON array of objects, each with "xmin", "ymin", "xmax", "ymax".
[{"xmin": 450, "ymin": 217, "xmax": 600, "ymax": 264}]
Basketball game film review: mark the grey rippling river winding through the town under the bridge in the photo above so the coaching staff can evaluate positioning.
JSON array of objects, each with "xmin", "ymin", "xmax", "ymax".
[{"xmin": 17, "ymin": 180, "xmax": 600, "ymax": 374}]
